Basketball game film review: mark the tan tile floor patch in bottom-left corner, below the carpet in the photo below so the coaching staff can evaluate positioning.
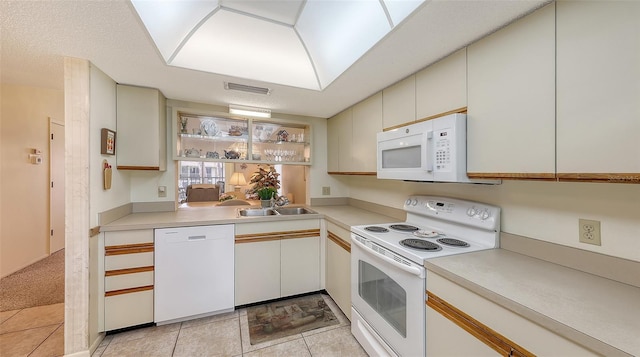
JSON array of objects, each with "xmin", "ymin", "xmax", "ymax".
[{"xmin": 0, "ymin": 303, "xmax": 64, "ymax": 357}]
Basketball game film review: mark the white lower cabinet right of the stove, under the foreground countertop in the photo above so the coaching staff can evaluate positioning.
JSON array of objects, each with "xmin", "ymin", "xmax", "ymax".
[{"xmin": 426, "ymin": 271, "xmax": 598, "ymax": 356}]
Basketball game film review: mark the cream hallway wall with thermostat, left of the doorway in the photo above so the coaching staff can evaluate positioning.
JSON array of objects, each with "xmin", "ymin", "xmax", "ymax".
[{"xmin": 0, "ymin": 83, "xmax": 64, "ymax": 277}]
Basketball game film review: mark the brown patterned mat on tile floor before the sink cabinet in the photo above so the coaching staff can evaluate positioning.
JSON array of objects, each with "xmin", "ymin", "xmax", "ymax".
[{"xmin": 247, "ymin": 294, "xmax": 340, "ymax": 345}]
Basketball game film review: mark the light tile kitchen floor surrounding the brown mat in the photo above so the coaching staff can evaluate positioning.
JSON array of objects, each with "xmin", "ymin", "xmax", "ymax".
[{"xmin": 92, "ymin": 295, "xmax": 367, "ymax": 357}]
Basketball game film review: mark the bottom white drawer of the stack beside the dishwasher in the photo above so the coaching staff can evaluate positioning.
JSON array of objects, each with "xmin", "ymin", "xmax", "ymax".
[{"xmin": 104, "ymin": 289, "xmax": 153, "ymax": 331}]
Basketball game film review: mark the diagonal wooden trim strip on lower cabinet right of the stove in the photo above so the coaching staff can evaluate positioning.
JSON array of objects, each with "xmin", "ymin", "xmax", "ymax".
[{"xmin": 426, "ymin": 290, "xmax": 535, "ymax": 357}]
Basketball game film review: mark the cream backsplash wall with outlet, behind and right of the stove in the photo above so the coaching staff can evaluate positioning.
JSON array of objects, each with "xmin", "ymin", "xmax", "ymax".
[{"xmin": 348, "ymin": 177, "xmax": 640, "ymax": 261}]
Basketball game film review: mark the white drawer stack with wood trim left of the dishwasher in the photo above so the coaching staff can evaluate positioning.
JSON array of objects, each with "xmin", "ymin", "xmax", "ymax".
[{"xmin": 103, "ymin": 229, "xmax": 154, "ymax": 331}]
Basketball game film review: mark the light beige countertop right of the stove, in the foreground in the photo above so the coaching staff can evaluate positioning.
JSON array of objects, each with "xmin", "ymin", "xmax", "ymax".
[{"xmin": 424, "ymin": 249, "xmax": 640, "ymax": 356}]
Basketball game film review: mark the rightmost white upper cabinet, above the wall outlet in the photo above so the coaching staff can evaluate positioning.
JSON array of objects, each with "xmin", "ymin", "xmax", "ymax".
[{"xmin": 556, "ymin": 1, "xmax": 640, "ymax": 183}]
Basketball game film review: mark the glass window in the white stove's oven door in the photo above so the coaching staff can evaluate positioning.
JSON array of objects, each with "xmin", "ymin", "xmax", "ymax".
[{"xmin": 358, "ymin": 260, "xmax": 407, "ymax": 338}]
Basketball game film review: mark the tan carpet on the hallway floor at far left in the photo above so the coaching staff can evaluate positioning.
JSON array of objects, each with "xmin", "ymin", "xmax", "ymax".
[{"xmin": 0, "ymin": 249, "xmax": 64, "ymax": 311}]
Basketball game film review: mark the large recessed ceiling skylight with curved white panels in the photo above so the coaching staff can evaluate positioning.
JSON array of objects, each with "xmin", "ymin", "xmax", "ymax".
[{"xmin": 132, "ymin": 0, "xmax": 424, "ymax": 90}]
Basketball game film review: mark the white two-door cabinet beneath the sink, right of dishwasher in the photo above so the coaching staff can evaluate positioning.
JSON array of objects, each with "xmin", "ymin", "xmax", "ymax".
[{"xmin": 235, "ymin": 219, "xmax": 320, "ymax": 306}]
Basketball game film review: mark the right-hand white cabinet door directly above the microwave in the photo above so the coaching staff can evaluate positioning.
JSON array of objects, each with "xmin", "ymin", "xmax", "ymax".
[{"xmin": 415, "ymin": 48, "xmax": 467, "ymax": 119}]
